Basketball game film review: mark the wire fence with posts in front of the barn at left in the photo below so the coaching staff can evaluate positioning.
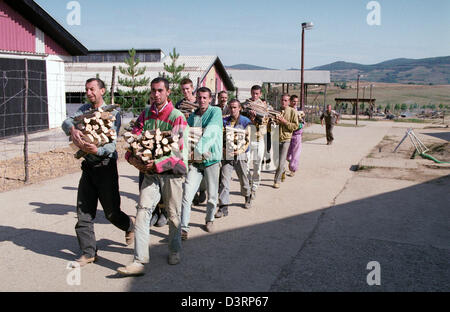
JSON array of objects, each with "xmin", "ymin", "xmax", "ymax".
[{"xmin": 0, "ymin": 64, "xmax": 151, "ymax": 191}]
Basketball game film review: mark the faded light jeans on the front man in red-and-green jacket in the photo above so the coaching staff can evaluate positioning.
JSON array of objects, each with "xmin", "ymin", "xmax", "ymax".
[{"xmin": 134, "ymin": 174, "xmax": 184, "ymax": 263}]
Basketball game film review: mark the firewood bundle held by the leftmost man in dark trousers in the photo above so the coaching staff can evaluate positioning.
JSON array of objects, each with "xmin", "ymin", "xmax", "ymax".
[{"xmin": 70, "ymin": 105, "xmax": 118, "ymax": 159}]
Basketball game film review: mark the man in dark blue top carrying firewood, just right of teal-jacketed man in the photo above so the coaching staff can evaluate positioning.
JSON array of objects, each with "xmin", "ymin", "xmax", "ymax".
[{"xmin": 215, "ymin": 99, "xmax": 251, "ymax": 218}]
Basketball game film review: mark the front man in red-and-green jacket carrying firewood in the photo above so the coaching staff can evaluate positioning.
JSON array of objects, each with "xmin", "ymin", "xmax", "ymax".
[{"xmin": 117, "ymin": 77, "xmax": 188, "ymax": 276}]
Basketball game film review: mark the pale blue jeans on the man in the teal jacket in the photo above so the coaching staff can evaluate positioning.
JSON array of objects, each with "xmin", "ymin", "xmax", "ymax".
[{"xmin": 181, "ymin": 162, "xmax": 220, "ymax": 232}]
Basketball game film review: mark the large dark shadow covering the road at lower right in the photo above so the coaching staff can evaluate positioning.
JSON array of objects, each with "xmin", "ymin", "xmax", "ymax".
[{"xmin": 117, "ymin": 175, "xmax": 450, "ymax": 292}]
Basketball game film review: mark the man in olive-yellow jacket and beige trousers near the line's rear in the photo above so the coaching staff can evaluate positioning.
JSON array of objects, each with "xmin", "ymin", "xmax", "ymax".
[{"xmin": 273, "ymin": 93, "xmax": 298, "ymax": 188}]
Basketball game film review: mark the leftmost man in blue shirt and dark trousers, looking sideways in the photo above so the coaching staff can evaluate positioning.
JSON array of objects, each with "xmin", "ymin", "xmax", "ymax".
[{"xmin": 62, "ymin": 78, "xmax": 134, "ymax": 266}]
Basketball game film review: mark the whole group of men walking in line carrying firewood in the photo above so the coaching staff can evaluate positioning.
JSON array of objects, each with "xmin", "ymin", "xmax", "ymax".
[{"xmin": 62, "ymin": 77, "xmax": 303, "ymax": 276}]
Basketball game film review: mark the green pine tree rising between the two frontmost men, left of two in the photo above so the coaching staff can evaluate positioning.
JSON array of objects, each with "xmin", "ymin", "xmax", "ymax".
[{"xmin": 115, "ymin": 49, "xmax": 150, "ymax": 116}]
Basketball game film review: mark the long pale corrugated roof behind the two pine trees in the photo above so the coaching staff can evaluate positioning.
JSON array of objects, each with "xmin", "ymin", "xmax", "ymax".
[{"xmin": 65, "ymin": 55, "xmax": 225, "ymax": 92}]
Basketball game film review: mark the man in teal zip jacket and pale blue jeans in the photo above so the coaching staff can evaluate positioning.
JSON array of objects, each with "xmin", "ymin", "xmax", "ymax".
[{"xmin": 181, "ymin": 87, "xmax": 223, "ymax": 240}]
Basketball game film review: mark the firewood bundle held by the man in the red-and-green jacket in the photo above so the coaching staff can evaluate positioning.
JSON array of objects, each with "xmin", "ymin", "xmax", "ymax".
[{"xmin": 123, "ymin": 129, "xmax": 179, "ymax": 164}]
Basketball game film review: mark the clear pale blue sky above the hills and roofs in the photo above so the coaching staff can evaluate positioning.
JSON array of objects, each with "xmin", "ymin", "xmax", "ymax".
[{"xmin": 35, "ymin": 0, "xmax": 450, "ymax": 69}]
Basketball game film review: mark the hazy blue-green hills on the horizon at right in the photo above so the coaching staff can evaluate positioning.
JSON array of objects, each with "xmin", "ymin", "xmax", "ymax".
[{"xmin": 312, "ymin": 56, "xmax": 450, "ymax": 84}]
